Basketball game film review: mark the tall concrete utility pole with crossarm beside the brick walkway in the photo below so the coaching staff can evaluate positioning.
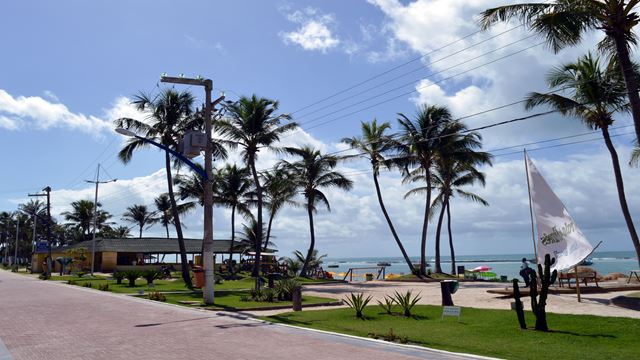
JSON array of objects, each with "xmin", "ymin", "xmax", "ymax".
[{"xmin": 160, "ymin": 76, "xmax": 224, "ymax": 305}]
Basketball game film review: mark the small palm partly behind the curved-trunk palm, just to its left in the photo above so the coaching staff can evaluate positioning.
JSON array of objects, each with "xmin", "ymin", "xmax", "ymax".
[{"xmin": 262, "ymin": 166, "xmax": 297, "ymax": 251}]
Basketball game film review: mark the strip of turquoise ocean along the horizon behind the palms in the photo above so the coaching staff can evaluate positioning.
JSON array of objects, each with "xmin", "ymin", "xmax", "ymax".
[{"xmin": 322, "ymin": 250, "xmax": 639, "ymax": 281}]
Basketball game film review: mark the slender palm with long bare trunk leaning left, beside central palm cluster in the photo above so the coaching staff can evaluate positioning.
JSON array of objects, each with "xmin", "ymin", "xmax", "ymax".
[{"xmin": 342, "ymin": 119, "xmax": 416, "ymax": 274}]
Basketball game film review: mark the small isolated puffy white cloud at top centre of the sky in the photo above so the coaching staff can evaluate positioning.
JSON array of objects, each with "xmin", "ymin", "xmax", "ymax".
[{"xmin": 280, "ymin": 7, "xmax": 340, "ymax": 53}]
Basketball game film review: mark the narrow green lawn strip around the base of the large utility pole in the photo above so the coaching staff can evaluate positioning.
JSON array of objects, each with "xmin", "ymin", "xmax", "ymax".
[{"xmin": 160, "ymin": 291, "xmax": 336, "ymax": 310}]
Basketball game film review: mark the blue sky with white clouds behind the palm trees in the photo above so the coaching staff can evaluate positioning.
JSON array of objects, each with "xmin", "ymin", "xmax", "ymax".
[{"xmin": 0, "ymin": 0, "xmax": 640, "ymax": 257}]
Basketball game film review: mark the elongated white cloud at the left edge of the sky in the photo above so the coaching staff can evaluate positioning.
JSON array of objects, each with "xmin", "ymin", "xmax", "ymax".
[{"xmin": 0, "ymin": 89, "xmax": 113, "ymax": 136}]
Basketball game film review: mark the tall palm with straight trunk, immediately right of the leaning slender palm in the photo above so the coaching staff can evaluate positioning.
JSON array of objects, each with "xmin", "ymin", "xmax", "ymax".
[{"xmin": 396, "ymin": 105, "xmax": 453, "ymax": 276}]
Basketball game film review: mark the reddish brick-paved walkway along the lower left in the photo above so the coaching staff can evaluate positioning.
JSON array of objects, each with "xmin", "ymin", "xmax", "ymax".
[{"xmin": 0, "ymin": 271, "xmax": 482, "ymax": 360}]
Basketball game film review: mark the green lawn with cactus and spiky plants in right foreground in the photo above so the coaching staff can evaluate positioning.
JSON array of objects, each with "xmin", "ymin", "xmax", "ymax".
[{"xmin": 264, "ymin": 305, "xmax": 640, "ymax": 359}]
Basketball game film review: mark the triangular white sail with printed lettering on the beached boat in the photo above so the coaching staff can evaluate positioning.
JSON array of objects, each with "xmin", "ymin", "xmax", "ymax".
[{"xmin": 525, "ymin": 154, "xmax": 593, "ymax": 271}]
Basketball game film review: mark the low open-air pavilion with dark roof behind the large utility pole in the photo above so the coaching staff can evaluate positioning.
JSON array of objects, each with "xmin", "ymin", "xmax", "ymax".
[{"xmin": 31, "ymin": 238, "xmax": 247, "ymax": 272}]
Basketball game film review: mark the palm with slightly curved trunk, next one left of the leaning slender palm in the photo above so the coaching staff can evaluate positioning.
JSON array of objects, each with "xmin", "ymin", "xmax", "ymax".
[{"xmin": 281, "ymin": 146, "xmax": 353, "ymax": 276}]
